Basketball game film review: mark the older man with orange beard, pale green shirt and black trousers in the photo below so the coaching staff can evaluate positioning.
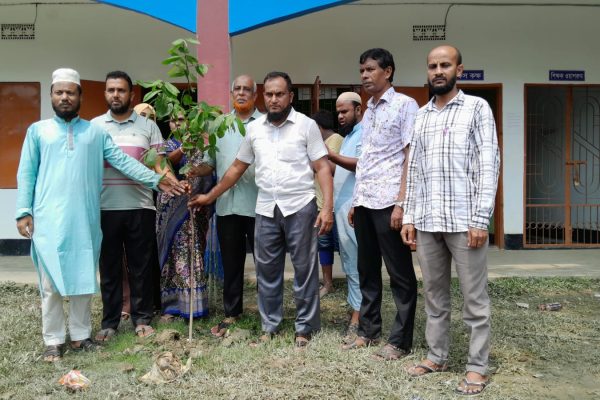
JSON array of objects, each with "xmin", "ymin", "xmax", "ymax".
[{"xmin": 191, "ymin": 75, "xmax": 262, "ymax": 337}]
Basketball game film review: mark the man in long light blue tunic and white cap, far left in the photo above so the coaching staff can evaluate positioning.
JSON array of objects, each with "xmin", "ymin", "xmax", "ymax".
[{"xmin": 16, "ymin": 68, "xmax": 184, "ymax": 362}]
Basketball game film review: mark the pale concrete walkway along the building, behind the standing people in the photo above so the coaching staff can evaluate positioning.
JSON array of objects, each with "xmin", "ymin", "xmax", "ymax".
[{"xmin": 0, "ymin": 247, "xmax": 600, "ymax": 284}]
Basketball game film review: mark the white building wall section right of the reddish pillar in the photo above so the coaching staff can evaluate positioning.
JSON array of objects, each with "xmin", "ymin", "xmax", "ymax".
[{"xmin": 232, "ymin": 1, "xmax": 600, "ymax": 234}]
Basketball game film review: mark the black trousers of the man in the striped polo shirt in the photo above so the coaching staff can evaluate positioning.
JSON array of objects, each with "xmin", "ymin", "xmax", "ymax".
[{"xmin": 100, "ymin": 209, "xmax": 158, "ymax": 329}]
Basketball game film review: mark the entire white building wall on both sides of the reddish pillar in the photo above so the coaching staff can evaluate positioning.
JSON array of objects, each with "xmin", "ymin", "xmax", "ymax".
[{"xmin": 0, "ymin": 0, "xmax": 600, "ymax": 239}]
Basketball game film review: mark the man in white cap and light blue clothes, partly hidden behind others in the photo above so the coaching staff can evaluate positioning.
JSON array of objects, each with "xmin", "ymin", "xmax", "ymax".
[{"xmin": 329, "ymin": 92, "xmax": 362, "ymax": 344}]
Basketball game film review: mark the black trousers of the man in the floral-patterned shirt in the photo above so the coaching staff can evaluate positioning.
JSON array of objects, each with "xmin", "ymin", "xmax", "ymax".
[{"xmin": 354, "ymin": 206, "xmax": 417, "ymax": 350}]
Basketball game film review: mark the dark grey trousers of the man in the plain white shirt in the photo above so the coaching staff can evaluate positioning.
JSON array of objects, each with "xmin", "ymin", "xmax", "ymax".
[{"xmin": 254, "ymin": 200, "xmax": 321, "ymax": 335}]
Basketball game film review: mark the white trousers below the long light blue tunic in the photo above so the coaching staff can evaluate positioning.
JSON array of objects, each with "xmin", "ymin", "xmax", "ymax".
[{"xmin": 39, "ymin": 267, "xmax": 92, "ymax": 346}]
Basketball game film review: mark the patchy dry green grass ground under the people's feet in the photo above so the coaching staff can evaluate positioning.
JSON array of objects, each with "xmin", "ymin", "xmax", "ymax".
[{"xmin": 0, "ymin": 278, "xmax": 600, "ymax": 399}]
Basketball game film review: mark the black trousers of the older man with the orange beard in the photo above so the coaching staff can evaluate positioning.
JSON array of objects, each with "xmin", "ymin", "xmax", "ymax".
[{"xmin": 217, "ymin": 215, "xmax": 254, "ymax": 317}]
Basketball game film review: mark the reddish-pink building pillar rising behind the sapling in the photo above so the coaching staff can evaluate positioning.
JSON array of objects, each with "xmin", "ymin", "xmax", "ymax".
[{"xmin": 196, "ymin": 0, "xmax": 231, "ymax": 112}]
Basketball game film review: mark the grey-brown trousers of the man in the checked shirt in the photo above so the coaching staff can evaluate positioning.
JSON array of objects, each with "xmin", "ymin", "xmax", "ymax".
[{"xmin": 417, "ymin": 231, "xmax": 491, "ymax": 375}]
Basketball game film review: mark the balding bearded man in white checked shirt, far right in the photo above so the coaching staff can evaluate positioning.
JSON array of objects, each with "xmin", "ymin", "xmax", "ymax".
[{"xmin": 400, "ymin": 46, "xmax": 500, "ymax": 395}]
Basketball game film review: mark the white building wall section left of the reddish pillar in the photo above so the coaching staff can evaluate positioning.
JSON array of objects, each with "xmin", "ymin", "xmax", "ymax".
[{"xmin": 0, "ymin": 2, "xmax": 194, "ymax": 239}]
